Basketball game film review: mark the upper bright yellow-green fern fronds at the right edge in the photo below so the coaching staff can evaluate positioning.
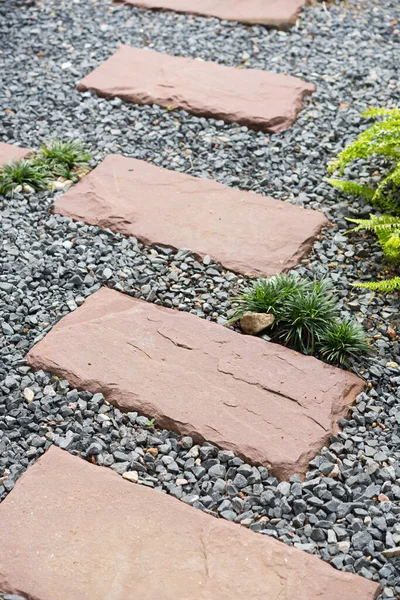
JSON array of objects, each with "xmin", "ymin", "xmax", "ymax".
[{"xmin": 327, "ymin": 108, "xmax": 400, "ymax": 214}]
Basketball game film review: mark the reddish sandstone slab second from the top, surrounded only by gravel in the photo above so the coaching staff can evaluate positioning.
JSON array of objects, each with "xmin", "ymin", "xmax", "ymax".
[{"xmin": 77, "ymin": 46, "xmax": 315, "ymax": 133}]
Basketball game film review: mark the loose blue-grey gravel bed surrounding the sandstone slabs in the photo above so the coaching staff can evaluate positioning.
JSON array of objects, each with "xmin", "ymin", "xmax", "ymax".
[{"xmin": 0, "ymin": 0, "xmax": 400, "ymax": 599}]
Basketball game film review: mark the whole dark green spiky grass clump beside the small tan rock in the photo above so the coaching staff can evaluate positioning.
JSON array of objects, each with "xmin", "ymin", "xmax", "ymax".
[{"xmin": 229, "ymin": 275, "xmax": 369, "ymax": 366}]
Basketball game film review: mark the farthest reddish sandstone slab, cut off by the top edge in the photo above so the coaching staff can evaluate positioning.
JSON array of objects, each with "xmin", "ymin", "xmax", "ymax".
[{"xmin": 125, "ymin": 0, "xmax": 306, "ymax": 29}]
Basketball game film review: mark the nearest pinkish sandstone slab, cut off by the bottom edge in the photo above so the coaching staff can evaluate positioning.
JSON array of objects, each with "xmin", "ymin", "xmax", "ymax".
[{"xmin": 0, "ymin": 446, "xmax": 379, "ymax": 600}]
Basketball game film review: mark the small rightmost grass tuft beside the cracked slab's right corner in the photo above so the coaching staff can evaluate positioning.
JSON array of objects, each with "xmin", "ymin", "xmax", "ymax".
[{"xmin": 318, "ymin": 320, "xmax": 370, "ymax": 367}]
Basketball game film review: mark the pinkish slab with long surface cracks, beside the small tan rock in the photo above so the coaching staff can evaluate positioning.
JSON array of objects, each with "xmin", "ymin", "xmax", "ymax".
[{"xmin": 27, "ymin": 288, "xmax": 364, "ymax": 478}]
